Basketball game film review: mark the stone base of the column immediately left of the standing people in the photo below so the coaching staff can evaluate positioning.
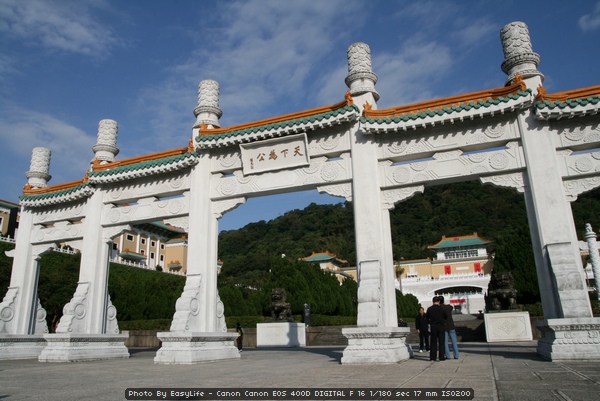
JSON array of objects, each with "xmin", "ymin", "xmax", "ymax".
[{"xmin": 342, "ymin": 327, "xmax": 413, "ymax": 365}]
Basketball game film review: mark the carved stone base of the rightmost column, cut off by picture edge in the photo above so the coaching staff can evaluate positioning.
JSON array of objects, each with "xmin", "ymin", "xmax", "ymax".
[{"xmin": 536, "ymin": 317, "xmax": 600, "ymax": 361}]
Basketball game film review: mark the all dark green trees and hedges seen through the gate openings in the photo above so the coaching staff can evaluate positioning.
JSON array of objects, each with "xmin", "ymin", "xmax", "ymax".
[{"xmin": 0, "ymin": 182, "xmax": 600, "ymax": 328}]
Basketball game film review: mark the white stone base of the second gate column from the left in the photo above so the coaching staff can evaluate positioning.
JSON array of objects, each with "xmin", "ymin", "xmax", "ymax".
[{"xmin": 39, "ymin": 333, "xmax": 129, "ymax": 362}]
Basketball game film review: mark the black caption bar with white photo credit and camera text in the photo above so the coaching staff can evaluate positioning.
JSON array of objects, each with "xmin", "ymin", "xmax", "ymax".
[{"xmin": 125, "ymin": 387, "xmax": 475, "ymax": 401}]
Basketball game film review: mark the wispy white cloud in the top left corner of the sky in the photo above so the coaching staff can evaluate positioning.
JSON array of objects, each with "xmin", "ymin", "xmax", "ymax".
[{"xmin": 0, "ymin": 0, "xmax": 120, "ymax": 57}]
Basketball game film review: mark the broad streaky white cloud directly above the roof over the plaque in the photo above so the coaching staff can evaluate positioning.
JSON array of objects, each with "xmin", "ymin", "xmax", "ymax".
[{"xmin": 134, "ymin": 0, "xmax": 362, "ymax": 136}]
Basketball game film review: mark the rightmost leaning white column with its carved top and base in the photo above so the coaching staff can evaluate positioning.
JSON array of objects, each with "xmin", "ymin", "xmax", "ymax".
[{"xmin": 500, "ymin": 22, "xmax": 600, "ymax": 360}]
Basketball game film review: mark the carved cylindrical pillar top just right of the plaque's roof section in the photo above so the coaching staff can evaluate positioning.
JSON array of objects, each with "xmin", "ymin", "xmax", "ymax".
[{"xmin": 346, "ymin": 42, "xmax": 379, "ymax": 101}]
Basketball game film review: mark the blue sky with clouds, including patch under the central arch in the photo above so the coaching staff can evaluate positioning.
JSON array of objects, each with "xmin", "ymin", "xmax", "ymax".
[{"xmin": 0, "ymin": 0, "xmax": 600, "ymax": 229}]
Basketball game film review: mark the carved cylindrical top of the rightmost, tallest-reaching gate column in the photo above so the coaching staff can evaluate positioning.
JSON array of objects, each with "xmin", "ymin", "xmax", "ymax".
[{"xmin": 500, "ymin": 21, "xmax": 544, "ymax": 88}]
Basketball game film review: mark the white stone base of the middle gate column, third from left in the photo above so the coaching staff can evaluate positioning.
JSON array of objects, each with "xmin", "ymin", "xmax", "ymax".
[{"xmin": 154, "ymin": 332, "xmax": 240, "ymax": 364}]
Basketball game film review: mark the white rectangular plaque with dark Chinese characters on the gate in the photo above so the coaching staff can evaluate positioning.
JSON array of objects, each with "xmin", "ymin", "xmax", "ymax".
[{"xmin": 240, "ymin": 134, "xmax": 310, "ymax": 175}]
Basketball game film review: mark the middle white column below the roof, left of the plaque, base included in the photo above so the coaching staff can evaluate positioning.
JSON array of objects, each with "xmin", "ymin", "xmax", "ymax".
[{"xmin": 154, "ymin": 152, "xmax": 240, "ymax": 364}]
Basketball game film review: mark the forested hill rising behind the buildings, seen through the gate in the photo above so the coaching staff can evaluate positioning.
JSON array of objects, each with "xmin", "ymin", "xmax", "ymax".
[{"xmin": 219, "ymin": 181, "xmax": 600, "ymax": 302}]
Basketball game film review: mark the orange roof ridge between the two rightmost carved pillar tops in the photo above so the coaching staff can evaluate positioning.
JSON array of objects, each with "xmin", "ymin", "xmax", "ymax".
[{"xmin": 363, "ymin": 79, "xmax": 527, "ymax": 117}]
